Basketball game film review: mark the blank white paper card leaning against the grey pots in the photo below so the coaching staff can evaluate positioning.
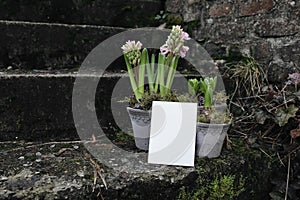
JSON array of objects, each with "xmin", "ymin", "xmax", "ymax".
[{"xmin": 148, "ymin": 101, "xmax": 197, "ymax": 166}]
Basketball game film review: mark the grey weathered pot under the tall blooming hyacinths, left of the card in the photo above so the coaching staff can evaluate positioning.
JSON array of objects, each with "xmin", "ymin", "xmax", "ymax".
[{"xmin": 127, "ymin": 107, "xmax": 151, "ymax": 151}]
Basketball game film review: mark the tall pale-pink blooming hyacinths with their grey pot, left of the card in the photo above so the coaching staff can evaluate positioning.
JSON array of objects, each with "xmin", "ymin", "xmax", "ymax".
[{"xmin": 121, "ymin": 26, "xmax": 190, "ymax": 150}]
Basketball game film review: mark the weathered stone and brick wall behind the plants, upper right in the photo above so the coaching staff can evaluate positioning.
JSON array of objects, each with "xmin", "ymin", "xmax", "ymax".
[{"xmin": 166, "ymin": 0, "xmax": 300, "ymax": 82}]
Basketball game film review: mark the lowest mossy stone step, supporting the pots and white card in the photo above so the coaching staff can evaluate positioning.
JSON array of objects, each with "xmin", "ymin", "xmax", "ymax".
[{"xmin": 0, "ymin": 140, "xmax": 285, "ymax": 200}]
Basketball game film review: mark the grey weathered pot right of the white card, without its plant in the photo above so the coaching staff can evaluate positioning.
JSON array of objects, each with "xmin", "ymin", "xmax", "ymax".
[{"xmin": 196, "ymin": 122, "xmax": 230, "ymax": 158}]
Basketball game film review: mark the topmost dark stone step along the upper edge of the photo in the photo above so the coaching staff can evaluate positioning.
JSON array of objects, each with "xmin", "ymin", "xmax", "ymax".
[{"xmin": 0, "ymin": 0, "xmax": 164, "ymax": 27}]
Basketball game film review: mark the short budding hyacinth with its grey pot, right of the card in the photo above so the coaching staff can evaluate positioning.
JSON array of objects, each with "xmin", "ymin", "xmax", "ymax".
[{"xmin": 188, "ymin": 77, "xmax": 231, "ymax": 158}]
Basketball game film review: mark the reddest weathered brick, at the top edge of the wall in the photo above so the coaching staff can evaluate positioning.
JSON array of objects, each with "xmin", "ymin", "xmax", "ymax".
[{"xmin": 239, "ymin": 0, "xmax": 275, "ymax": 16}]
